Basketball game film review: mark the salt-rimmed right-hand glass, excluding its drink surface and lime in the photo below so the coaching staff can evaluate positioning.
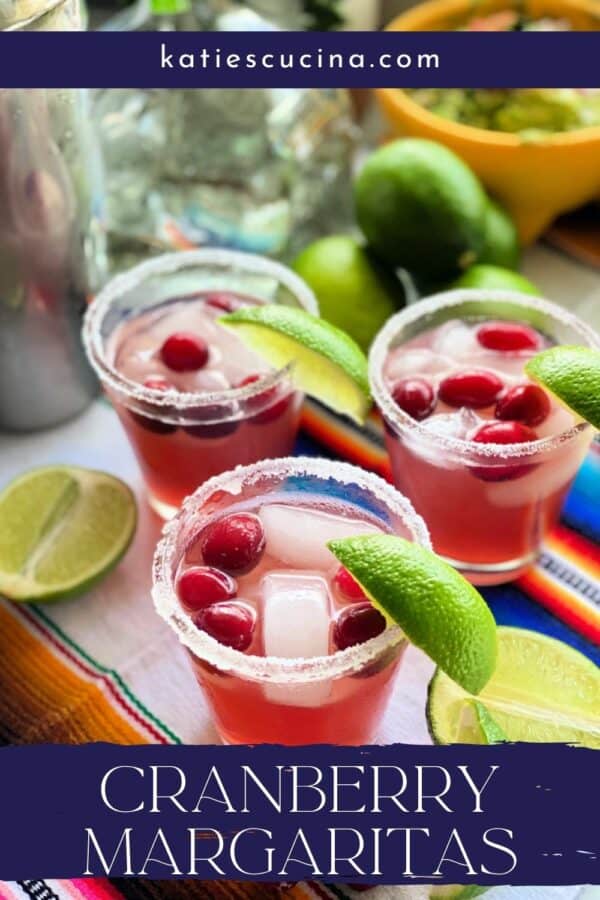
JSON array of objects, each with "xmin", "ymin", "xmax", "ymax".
[{"xmin": 369, "ymin": 290, "xmax": 600, "ymax": 584}]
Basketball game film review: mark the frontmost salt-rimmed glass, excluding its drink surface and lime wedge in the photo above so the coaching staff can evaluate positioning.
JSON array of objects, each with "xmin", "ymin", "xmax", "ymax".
[{"xmin": 153, "ymin": 457, "xmax": 430, "ymax": 744}]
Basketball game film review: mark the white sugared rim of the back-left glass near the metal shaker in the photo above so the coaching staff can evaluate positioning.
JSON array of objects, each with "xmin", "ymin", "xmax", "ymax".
[{"xmin": 82, "ymin": 248, "xmax": 319, "ymax": 413}]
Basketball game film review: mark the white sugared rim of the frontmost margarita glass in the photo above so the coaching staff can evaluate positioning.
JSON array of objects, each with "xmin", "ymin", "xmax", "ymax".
[{"xmin": 152, "ymin": 456, "xmax": 431, "ymax": 684}]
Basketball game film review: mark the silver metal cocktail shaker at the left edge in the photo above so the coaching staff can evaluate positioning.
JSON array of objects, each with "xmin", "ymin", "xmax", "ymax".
[{"xmin": 0, "ymin": 89, "xmax": 105, "ymax": 430}]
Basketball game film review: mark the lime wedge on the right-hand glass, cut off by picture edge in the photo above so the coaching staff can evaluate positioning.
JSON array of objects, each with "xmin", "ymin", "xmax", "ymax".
[{"xmin": 525, "ymin": 346, "xmax": 600, "ymax": 428}]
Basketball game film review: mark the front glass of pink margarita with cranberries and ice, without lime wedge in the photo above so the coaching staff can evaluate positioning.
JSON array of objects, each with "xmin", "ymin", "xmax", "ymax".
[{"xmin": 153, "ymin": 457, "xmax": 429, "ymax": 744}]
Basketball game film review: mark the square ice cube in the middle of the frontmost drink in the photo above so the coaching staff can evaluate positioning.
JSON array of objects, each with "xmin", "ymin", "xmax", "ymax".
[{"xmin": 261, "ymin": 571, "xmax": 331, "ymax": 706}]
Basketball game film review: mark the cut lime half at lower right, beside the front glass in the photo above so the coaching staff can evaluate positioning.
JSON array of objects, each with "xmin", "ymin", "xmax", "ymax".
[{"xmin": 427, "ymin": 628, "xmax": 600, "ymax": 749}]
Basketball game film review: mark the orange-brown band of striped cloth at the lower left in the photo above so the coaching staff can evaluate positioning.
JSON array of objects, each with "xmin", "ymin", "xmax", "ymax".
[{"xmin": 0, "ymin": 605, "xmax": 148, "ymax": 744}]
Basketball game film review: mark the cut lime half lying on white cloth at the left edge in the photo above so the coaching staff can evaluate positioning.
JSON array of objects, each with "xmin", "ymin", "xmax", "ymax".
[{"xmin": 0, "ymin": 466, "xmax": 137, "ymax": 602}]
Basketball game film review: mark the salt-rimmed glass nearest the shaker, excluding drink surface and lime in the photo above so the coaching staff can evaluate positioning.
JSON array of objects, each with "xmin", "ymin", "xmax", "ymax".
[{"xmin": 83, "ymin": 249, "xmax": 318, "ymax": 518}]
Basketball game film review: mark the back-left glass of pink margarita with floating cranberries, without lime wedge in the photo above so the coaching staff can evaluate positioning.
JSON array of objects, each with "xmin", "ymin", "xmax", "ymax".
[{"xmin": 84, "ymin": 249, "xmax": 318, "ymax": 518}]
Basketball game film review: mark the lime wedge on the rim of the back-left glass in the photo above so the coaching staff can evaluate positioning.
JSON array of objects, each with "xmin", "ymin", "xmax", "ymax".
[{"xmin": 219, "ymin": 303, "xmax": 371, "ymax": 424}]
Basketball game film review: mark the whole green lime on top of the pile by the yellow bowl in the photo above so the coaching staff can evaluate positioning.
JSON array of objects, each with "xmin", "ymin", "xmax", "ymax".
[{"xmin": 355, "ymin": 138, "xmax": 487, "ymax": 282}]
